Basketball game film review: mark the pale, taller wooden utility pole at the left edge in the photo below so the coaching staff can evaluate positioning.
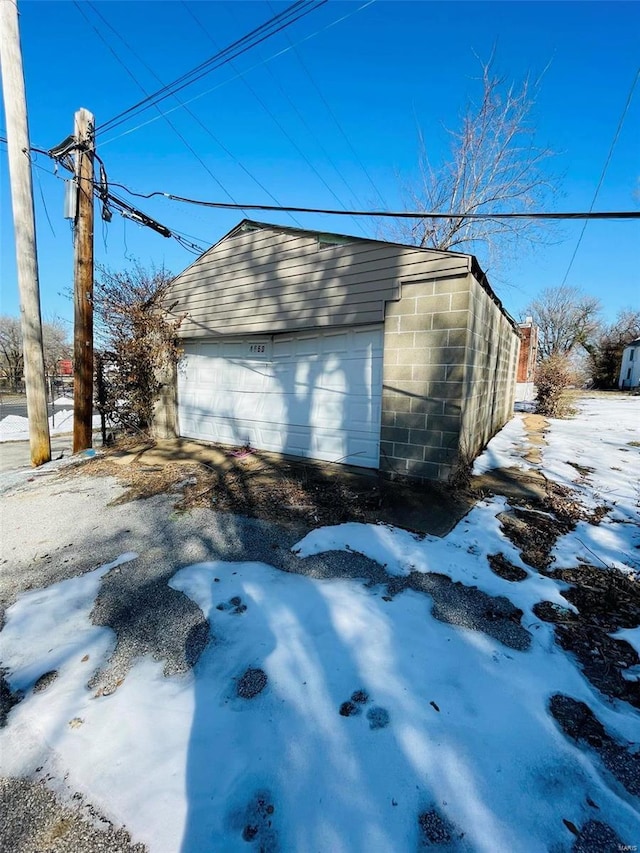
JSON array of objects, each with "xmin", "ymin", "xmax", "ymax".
[{"xmin": 0, "ymin": 0, "xmax": 51, "ymax": 465}]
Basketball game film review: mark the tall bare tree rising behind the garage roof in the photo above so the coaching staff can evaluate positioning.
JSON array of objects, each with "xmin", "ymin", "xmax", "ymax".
[{"xmin": 392, "ymin": 57, "xmax": 556, "ymax": 263}]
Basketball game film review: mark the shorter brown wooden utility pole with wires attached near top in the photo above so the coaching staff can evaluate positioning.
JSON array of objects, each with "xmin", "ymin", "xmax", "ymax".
[{"xmin": 72, "ymin": 108, "xmax": 95, "ymax": 453}]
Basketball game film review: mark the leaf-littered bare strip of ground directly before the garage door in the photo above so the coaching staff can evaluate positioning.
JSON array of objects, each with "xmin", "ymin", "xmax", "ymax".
[{"xmin": 77, "ymin": 439, "xmax": 475, "ymax": 536}]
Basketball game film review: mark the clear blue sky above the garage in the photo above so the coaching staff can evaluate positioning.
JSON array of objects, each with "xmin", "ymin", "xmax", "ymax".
[{"xmin": 0, "ymin": 0, "xmax": 640, "ymax": 332}]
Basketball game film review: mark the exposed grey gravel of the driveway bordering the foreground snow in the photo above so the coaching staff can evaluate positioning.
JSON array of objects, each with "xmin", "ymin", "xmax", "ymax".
[{"xmin": 0, "ymin": 452, "xmax": 530, "ymax": 853}]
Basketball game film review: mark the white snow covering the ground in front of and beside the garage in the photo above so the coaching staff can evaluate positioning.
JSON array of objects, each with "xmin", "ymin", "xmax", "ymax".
[{"xmin": 0, "ymin": 397, "xmax": 640, "ymax": 853}]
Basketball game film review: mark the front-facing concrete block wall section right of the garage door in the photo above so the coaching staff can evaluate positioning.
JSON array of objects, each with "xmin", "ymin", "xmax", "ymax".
[{"xmin": 380, "ymin": 274, "xmax": 471, "ymax": 480}]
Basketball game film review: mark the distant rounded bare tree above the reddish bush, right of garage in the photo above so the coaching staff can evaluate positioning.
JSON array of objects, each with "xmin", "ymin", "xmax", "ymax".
[{"xmin": 524, "ymin": 287, "xmax": 601, "ymax": 361}]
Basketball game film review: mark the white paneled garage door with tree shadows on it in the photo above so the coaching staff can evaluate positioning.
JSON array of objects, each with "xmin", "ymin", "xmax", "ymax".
[{"xmin": 178, "ymin": 326, "xmax": 382, "ymax": 468}]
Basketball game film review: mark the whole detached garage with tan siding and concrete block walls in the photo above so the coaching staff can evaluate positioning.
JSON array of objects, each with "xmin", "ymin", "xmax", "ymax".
[{"xmin": 160, "ymin": 219, "xmax": 520, "ymax": 482}]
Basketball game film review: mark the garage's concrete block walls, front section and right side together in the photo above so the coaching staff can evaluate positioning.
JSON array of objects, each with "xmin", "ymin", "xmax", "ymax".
[{"xmin": 380, "ymin": 273, "xmax": 519, "ymax": 480}]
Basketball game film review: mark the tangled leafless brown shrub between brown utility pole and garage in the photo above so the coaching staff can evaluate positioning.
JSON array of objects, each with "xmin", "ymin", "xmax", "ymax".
[{"xmin": 94, "ymin": 262, "xmax": 182, "ymax": 432}]
